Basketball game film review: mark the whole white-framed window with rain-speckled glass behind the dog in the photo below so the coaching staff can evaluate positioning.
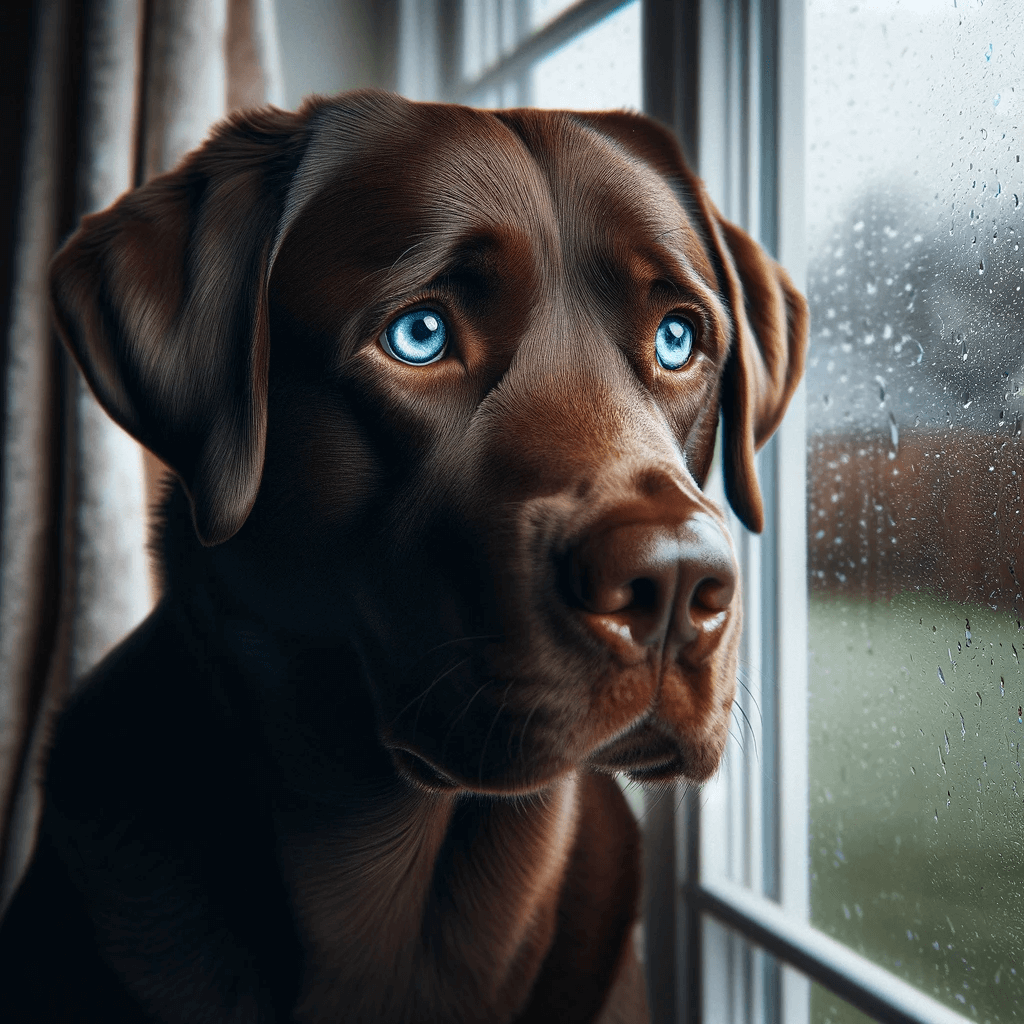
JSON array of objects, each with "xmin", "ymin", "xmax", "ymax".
[{"xmin": 398, "ymin": 0, "xmax": 1024, "ymax": 1024}]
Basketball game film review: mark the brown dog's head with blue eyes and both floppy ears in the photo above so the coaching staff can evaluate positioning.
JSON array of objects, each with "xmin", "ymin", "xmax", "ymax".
[{"xmin": 53, "ymin": 92, "xmax": 806, "ymax": 793}]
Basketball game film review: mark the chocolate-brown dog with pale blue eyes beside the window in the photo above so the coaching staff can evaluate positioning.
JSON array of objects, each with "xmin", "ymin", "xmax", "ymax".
[{"xmin": 0, "ymin": 92, "xmax": 806, "ymax": 1024}]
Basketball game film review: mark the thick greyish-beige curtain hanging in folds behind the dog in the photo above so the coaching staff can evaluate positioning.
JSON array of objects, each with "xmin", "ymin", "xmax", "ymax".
[{"xmin": 0, "ymin": 0, "xmax": 282, "ymax": 910}]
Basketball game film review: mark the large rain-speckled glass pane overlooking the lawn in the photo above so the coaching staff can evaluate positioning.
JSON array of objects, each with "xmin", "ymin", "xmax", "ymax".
[{"xmin": 807, "ymin": 0, "xmax": 1024, "ymax": 1022}]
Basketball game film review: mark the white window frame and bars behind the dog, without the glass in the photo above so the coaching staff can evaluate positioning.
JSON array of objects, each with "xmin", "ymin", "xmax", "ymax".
[{"xmin": 398, "ymin": 0, "xmax": 968, "ymax": 1024}]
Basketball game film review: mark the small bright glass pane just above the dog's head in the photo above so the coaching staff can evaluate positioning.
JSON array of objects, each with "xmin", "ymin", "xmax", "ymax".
[{"xmin": 530, "ymin": 0, "xmax": 642, "ymax": 111}]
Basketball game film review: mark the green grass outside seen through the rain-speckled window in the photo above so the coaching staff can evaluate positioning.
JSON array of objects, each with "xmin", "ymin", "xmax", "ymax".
[{"xmin": 809, "ymin": 594, "xmax": 1024, "ymax": 1024}]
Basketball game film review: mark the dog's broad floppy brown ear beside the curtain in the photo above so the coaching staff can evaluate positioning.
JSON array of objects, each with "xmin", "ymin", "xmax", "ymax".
[{"xmin": 50, "ymin": 109, "xmax": 307, "ymax": 545}]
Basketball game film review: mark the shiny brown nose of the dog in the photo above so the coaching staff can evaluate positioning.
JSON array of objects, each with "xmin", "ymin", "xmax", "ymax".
[{"xmin": 570, "ymin": 512, "xmax": 736, "ymax": 664}]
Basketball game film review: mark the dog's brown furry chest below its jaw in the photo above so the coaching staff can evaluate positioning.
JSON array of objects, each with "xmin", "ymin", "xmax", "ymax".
[{"xmin": 279, "ymin": 780, "xmax": 577, "ymax": 1022}]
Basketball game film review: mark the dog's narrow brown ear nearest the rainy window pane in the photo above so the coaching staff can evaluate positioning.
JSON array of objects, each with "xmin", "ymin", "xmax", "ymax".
[{"xmin": 575, "ymin": 112, "xmax": 808, "ymax": 534}]
